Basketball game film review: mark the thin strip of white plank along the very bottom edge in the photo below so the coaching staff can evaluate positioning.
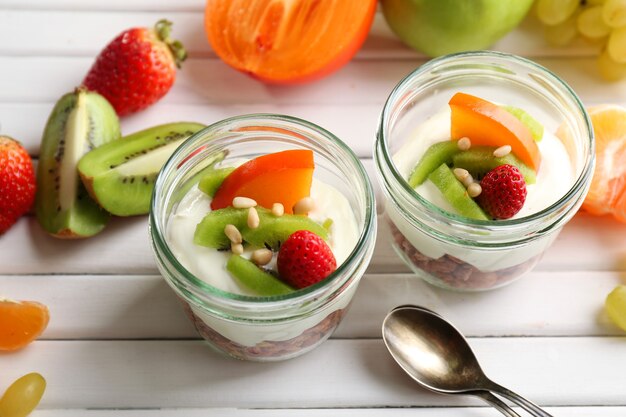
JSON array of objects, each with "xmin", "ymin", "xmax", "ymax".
[{"xmin": 24, "ymin": 407, "xmax": 626, "ymax": 417}]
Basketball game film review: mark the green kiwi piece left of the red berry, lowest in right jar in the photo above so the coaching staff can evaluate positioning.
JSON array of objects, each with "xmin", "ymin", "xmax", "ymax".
[{"xmin": 428, "ymin": 163, "xmax": 489, "ymax": 220}]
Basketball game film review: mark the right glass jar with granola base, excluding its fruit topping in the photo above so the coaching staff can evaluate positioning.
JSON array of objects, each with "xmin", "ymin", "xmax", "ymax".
[{"xmin": 374, "ymin": 51, "xmax": 595, "ymax": 291}]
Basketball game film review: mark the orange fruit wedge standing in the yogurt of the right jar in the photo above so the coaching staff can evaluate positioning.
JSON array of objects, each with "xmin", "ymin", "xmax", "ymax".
[{"xmin": 448, "ymin": 93, "xmax": 541, "ymax": 172}]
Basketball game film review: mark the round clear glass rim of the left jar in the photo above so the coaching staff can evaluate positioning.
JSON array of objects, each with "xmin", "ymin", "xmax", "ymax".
[{"xmin": 150, "ymin": 113, "xmax": 376, "ymax": 309}]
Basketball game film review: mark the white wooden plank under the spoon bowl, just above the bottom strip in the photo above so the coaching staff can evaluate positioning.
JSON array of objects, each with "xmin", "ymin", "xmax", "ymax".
[{"xmin": 0, "ymin": 337, "xmax": 626, "ymax": 409}]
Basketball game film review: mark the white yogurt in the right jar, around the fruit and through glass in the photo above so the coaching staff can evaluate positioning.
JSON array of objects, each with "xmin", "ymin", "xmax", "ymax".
[{"xmin": 387, "ymin": 106, "xmax": 574, "ymax": 272}]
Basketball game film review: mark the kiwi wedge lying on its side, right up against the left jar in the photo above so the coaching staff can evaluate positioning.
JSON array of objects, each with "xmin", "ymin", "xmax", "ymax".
[{"xmin": 78, "ymin": 122, "xmax": 205, "ymax": 216}]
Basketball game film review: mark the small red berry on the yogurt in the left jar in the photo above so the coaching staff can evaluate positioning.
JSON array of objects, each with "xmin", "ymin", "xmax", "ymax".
[{"xmin": 276, "ymin": 230, "xmax": 337, "ymax": 288}]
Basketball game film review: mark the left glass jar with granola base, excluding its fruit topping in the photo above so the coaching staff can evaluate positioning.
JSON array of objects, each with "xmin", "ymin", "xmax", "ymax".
[{"xmin": 150, "ymin": 114, "xmax": 376, "ymax": 361}]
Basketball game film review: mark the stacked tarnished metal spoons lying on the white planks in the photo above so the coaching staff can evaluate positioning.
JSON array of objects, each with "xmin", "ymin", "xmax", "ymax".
[{"xmin": 383, "ymin": 306, "xmax": 552, "ymax": 417}]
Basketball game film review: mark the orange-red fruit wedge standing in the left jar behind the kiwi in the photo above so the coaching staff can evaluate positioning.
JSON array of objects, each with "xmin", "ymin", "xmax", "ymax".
[{"xmin": 211, "ymin": 149, "xmax": 315, "ymax": 214}]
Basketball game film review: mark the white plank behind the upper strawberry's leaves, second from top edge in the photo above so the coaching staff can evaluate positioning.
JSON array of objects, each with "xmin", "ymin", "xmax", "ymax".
[{"xmin": 0, "ymin": 9, "xmax": 599, "ymax": 59}]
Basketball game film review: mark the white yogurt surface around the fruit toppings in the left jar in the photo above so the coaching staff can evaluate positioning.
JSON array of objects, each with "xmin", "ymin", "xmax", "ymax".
[{"xmin": 167, "ymin": 179, "xmax": 359, "ymax": 295}]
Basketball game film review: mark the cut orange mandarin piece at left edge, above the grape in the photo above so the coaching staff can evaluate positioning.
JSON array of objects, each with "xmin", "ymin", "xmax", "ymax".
[{"xmin": 0, "ymin": 299, "xmax": 50, "ymax": 352}]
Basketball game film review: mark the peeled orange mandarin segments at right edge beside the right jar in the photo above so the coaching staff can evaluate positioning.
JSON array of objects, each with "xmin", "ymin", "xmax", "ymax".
[{"xmin": 583, "ymin": 105, "xmax": 626, "ymax": 221}]
